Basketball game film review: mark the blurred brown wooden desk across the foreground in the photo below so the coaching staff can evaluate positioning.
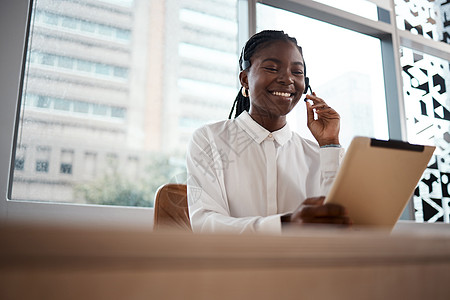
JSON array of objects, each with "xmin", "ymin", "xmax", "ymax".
[{"xmin": 0, "ymin": 221, "xmax": 450, "ymax": 299}]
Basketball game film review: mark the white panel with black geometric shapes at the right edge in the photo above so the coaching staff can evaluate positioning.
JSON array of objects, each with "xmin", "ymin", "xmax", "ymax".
[{"xmin": 395, "ymin": 0, "xmax": 450, "ymax": 223}]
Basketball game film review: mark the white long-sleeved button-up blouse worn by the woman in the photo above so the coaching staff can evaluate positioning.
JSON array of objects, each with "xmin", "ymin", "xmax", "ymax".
[{"xmin": 187, "ymin": 111, "xmax": 344, "ymax": 233}]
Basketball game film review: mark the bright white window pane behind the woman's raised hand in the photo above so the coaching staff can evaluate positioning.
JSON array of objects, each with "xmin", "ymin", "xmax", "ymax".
[{"xmin": 257, "ymin": 5, "xmax": 388, "ymax": 146}]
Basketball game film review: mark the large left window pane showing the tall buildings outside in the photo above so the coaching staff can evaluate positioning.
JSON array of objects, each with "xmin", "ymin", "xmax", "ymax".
[{"xmin": 11, "ymin": 0, "xmax": 239, "ymax": 206}]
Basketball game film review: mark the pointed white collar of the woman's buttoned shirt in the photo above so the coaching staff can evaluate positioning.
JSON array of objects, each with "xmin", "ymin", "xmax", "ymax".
[{"xmin": 236, "ymin": 111, "xmax": 292, "ymax": 146}]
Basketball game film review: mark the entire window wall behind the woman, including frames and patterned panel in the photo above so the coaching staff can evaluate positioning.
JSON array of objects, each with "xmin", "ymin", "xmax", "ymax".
[{"xmin": 0, "ymin": 0, "xmax": 450, "ymax": 224}]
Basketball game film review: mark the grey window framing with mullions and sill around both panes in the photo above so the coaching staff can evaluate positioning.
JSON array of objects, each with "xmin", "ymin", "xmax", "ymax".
[{"xmin": 0, "ymin": 0, "xmax": 450, "ymax": 228}]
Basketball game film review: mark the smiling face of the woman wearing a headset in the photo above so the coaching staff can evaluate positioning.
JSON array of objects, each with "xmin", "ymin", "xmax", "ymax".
[{"xmin": 239, "ymin": 41, "xmax": 305, "ymax": 121}]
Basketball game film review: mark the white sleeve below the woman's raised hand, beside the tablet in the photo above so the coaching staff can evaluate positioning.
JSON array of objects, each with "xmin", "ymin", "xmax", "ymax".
[{"xmin": 319, "ymin": 147, "xmax": 345, "ymax": 195}]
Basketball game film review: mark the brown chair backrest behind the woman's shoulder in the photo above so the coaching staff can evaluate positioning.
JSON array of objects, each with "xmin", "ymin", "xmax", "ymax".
[{"xmin": 153, "ymin": 183, "xmax": 191, "ymax": 231}]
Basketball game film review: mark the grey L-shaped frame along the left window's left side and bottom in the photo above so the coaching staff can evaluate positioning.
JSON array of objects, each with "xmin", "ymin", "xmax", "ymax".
[{"xmin": 0, "ymin": 0, "xmax": 153, "ymax": 228}]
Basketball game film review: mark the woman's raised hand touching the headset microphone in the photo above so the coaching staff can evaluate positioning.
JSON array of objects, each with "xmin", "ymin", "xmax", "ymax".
[{"xmin": 306, "ymin": 93, "xmax": 340, "ymax": 146}]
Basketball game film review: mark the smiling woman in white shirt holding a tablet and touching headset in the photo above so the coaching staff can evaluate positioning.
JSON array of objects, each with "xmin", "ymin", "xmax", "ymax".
[{"xmin": 187, "ymin": 30, "xmax": 350, "ymax": 233}]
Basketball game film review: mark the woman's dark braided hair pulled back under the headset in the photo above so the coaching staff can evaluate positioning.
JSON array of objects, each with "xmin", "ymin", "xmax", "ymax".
[{"xmin": 228, "ymin": 30, "xmax": 307, "ymax": 119}]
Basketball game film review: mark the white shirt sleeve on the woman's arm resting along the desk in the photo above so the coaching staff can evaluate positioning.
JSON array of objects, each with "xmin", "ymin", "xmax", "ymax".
[{"xmin": 186, "ymin": 127, "xmax": 281, "ymax": 234}]
